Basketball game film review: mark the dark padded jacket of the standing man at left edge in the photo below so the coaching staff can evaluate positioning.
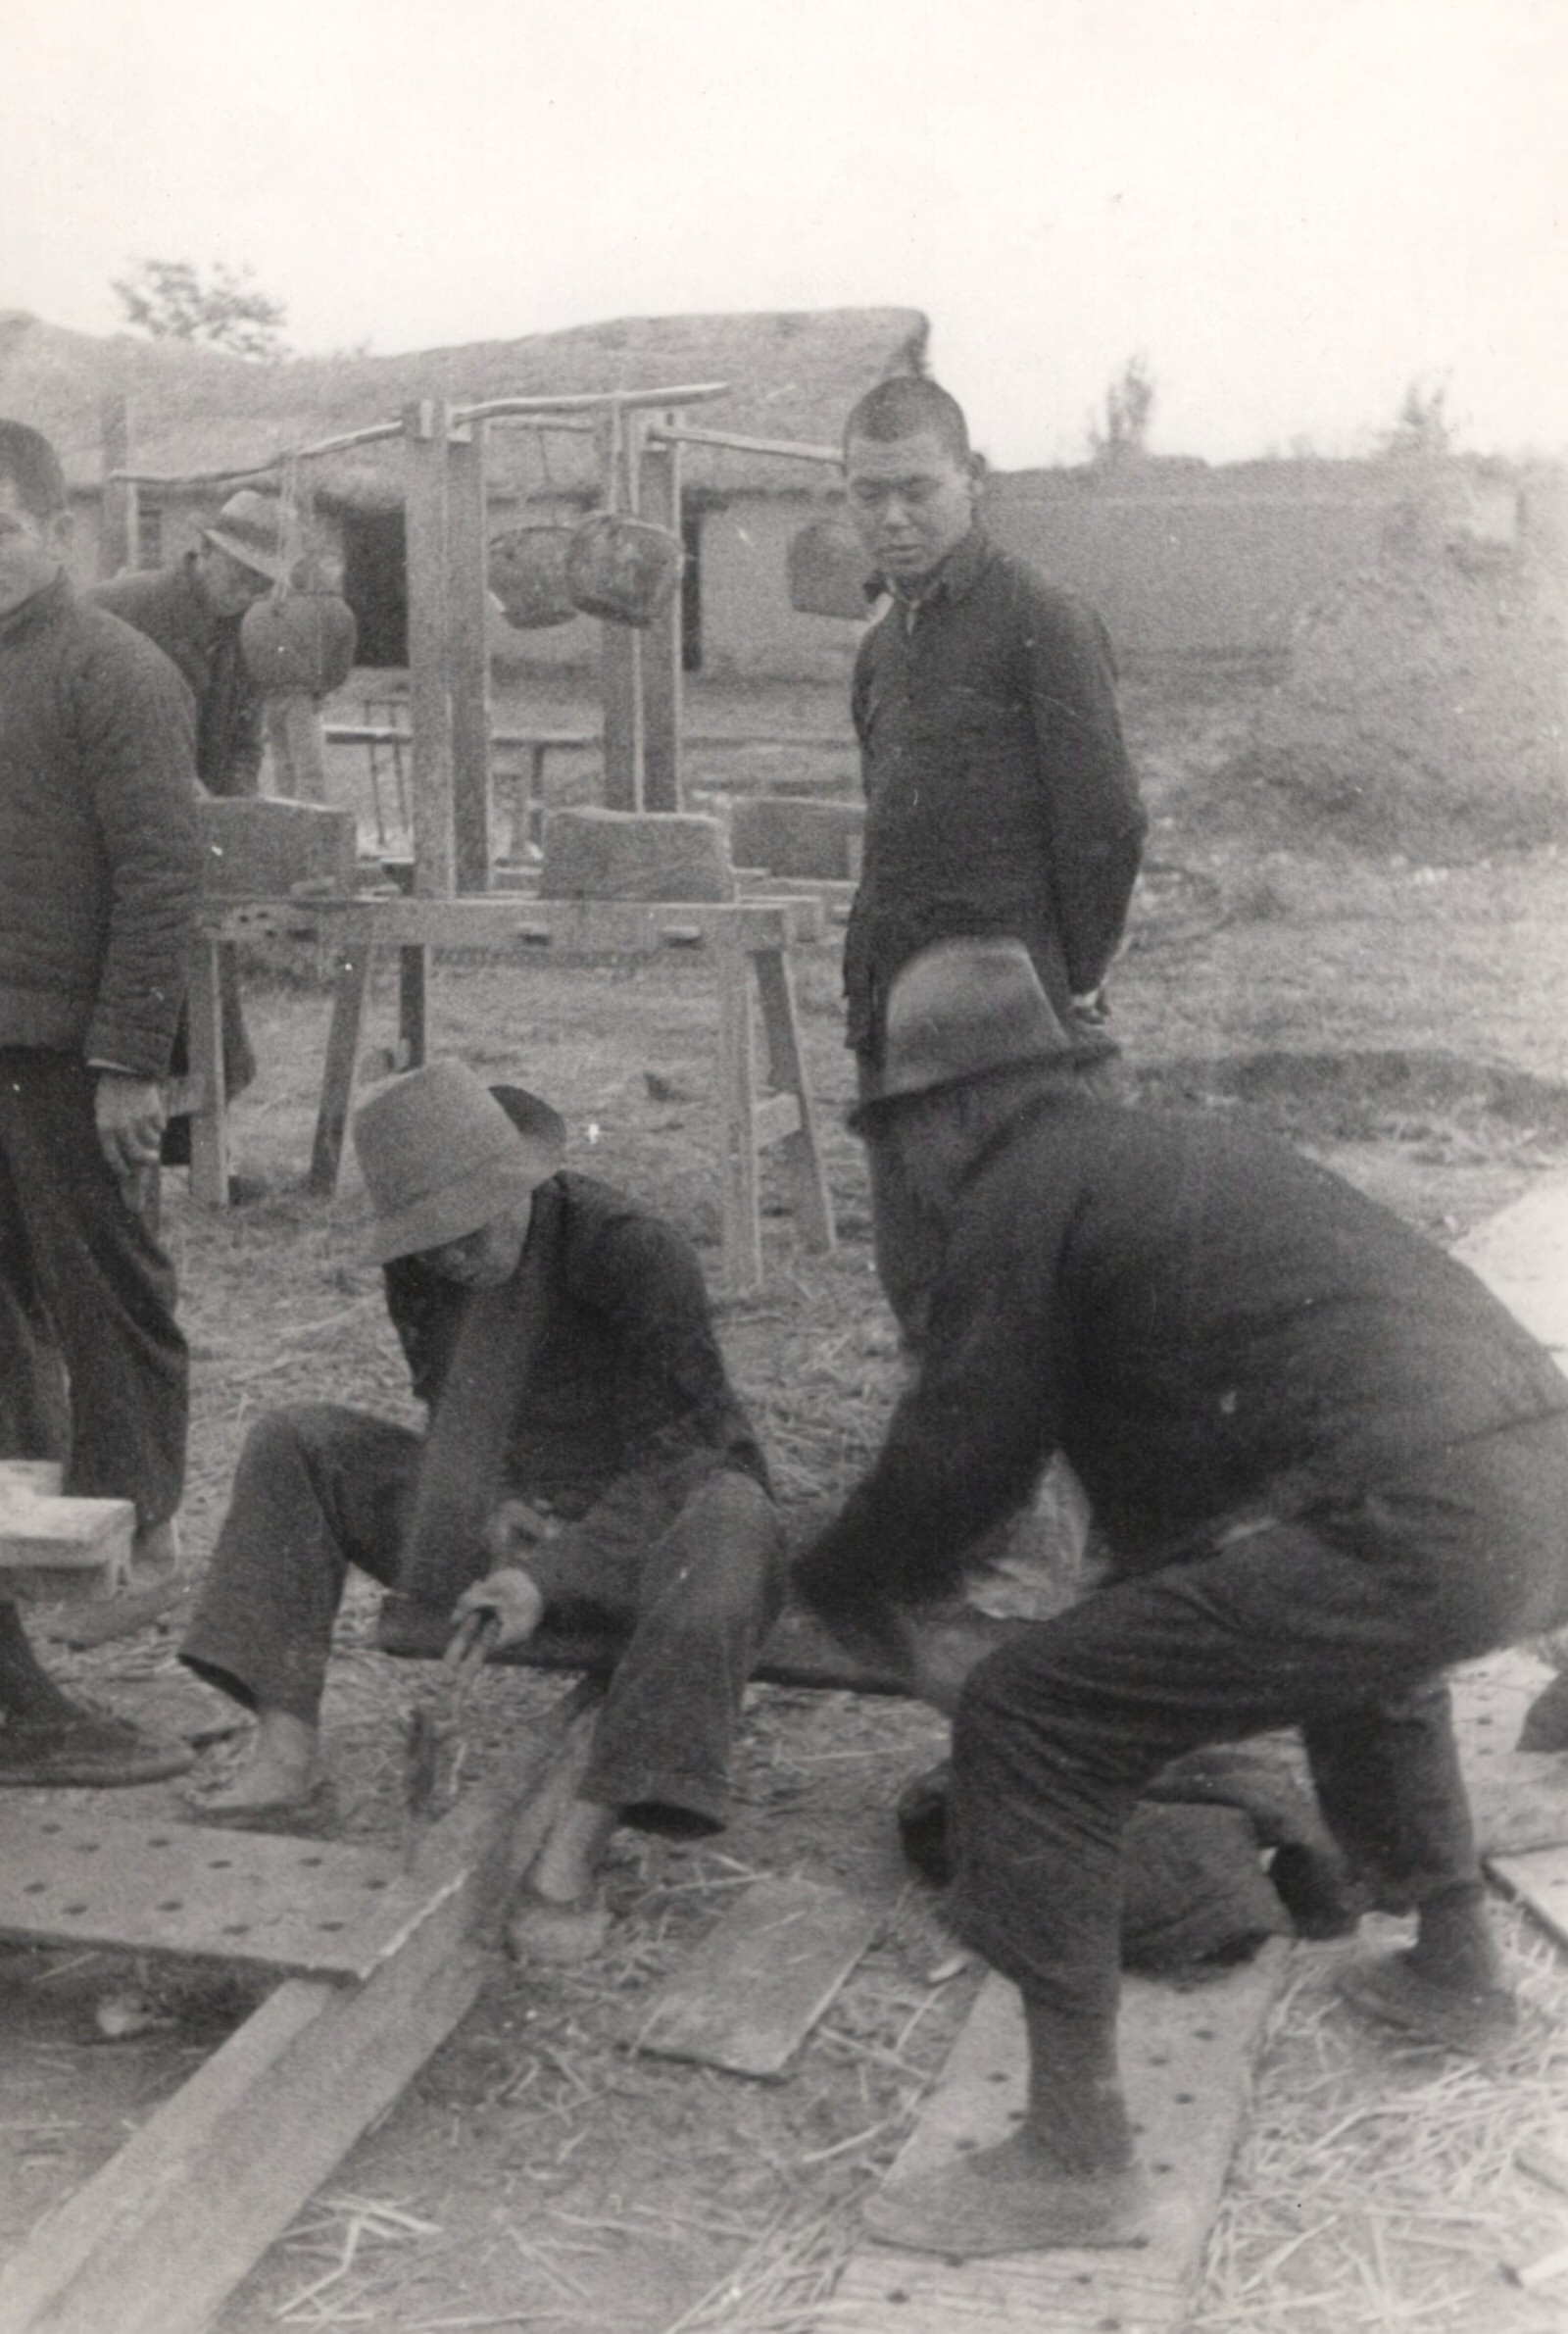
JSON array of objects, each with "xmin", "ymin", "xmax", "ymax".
[{"xmin": 0, "ymin": 578, "xmax": 201, "ymax": 1078}]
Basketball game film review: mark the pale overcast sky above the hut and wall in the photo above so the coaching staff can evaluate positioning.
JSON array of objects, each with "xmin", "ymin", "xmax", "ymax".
[{"xmin": 0, "ymin": 0, "xmax": 1568, "ymax": 467}]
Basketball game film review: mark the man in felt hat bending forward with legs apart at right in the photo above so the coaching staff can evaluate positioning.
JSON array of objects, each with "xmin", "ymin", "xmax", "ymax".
[{"xmin": 798, "ymin": 941, "xmax": 1568, "ymax": 2255}]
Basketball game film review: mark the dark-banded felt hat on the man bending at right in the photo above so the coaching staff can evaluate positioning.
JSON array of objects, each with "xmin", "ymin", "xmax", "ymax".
[{"xmin": 850, "ymin": 938, "xmax": 1097, "ymax": 1129}]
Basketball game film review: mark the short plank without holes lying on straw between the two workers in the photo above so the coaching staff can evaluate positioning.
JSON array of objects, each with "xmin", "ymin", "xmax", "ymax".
[{"xmin": 632, "ymin": 1879, "xmax": 882, "ymax": 2075}]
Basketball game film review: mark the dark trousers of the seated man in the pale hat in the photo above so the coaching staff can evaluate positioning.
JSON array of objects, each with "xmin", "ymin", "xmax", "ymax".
[{"xmin": 182, "ymin": 1403, "xmax": 784, "ymax": 1832}]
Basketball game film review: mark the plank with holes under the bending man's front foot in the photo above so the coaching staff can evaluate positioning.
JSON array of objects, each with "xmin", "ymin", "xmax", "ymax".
[{"xmin": 831, "ymin": 1940, "xmax": 1288, "ymax": 2334}]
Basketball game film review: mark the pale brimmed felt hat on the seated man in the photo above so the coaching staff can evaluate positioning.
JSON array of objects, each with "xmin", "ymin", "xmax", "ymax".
[{"xmin": 353, "ymin": 1060, "xmax": 567, "ymax": 1266}]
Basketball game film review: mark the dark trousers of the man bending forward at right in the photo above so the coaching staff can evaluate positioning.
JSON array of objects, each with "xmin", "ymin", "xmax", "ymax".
[{"xmin": 952, "ymin": 1416, "xmax": 1568, "ymax": 2016}]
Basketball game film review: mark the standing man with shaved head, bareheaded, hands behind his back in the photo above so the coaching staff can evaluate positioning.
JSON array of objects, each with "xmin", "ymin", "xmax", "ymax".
[{"xmin": 845, "ymin": 375, "xmax": 1146, "ymax": 1344}]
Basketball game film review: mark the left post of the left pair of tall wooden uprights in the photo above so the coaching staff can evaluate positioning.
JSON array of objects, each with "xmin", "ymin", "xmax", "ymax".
[{"xmin": 404, "ymin": 399, "xmax": 458, "ymax": 899}]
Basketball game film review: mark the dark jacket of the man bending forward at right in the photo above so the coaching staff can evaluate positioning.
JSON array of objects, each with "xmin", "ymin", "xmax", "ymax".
[{"xmin": 801, "ymin": 1092, "xmax": 1568, "ymax": 1611}]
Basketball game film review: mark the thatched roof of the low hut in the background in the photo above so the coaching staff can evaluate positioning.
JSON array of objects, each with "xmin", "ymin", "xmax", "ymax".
[{"xmin": 0, "ymin": 308, "xmax": 929, "ymax": 511}]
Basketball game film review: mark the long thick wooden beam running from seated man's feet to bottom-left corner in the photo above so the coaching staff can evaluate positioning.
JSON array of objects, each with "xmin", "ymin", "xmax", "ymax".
[{"xmin": 0, "ymin": 1687, "xmax": 595, "ymax": 2334}]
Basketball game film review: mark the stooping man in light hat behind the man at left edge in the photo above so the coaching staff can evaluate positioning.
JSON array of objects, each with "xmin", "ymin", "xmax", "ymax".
[{"xmin": 88, "ymin": 488, "xmax": 284, "ymax": 1200}]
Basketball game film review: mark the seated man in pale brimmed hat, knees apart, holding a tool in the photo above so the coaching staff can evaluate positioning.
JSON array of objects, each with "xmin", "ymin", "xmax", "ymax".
[{"xmin": 182, "ymin": 1060, "xmax": 784, "ymax": 1961}]
